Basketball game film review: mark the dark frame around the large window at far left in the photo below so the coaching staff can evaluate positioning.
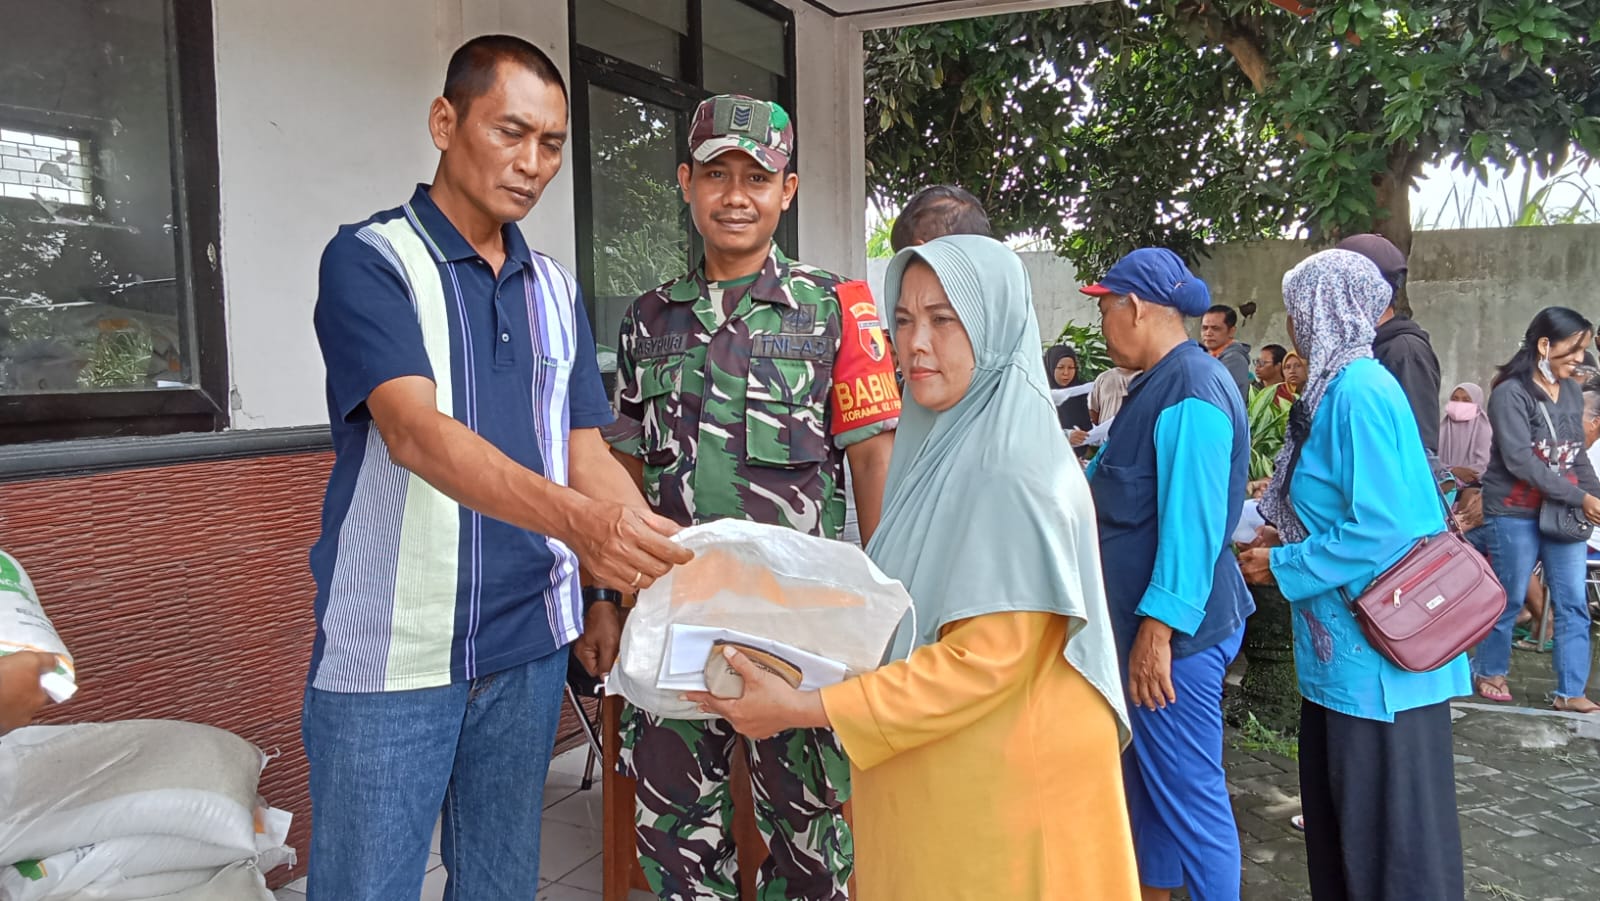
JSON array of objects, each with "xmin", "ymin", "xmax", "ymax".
[{"xmin": 0, "ymin": 0, "xmax": 229, "ymax": 445}]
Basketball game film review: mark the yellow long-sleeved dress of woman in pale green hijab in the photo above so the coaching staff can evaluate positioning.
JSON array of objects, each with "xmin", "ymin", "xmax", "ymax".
[{"xmin": 822, "ymin": 613, "xmax": 1139, "ymax": 901}]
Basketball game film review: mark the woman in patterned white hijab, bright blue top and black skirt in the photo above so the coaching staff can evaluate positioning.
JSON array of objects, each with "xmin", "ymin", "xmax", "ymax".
[{"xmin": 1238, "ymin": 250, "xmax": 1472, "ymax": 901}]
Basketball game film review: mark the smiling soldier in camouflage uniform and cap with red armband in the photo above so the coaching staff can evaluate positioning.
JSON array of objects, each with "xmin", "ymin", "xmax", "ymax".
[{"xmin": 611, "ymin": 96, "xmax": 899, "ymax": 901}]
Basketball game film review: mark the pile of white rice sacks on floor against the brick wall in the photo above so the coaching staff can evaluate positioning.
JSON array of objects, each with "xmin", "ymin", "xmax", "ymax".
[{"xmin": 0, "ymin": 720, "xmax": 294, "ymax": 901}]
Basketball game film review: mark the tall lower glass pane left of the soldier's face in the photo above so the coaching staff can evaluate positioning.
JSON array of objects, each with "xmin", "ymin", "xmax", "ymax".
[{"xmin": 589, "ymin": 85, "xmax": 690, "ymax": 361}]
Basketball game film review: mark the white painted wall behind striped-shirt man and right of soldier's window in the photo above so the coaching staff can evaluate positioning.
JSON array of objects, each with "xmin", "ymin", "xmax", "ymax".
[{"xmin": 216, "ymin": 0, "xmax": 866, "ymax": 429}]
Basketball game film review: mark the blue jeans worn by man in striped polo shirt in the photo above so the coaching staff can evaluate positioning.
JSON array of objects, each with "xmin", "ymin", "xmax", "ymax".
[{"xmin": 301, "ymin": 648, "xmax": 566, "ymax": 901}]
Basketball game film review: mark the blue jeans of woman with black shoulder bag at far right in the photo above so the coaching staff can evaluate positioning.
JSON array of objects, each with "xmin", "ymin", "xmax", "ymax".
[{"xmin": 1472, "ymin": 517, "xmax": 1589, "ymax": 698}]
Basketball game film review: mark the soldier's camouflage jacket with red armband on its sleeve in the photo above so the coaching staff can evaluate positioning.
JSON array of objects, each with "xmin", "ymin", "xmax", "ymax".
[{"xmin": 608, "ymin": 246, "xmax": 899, "ymax": 538}]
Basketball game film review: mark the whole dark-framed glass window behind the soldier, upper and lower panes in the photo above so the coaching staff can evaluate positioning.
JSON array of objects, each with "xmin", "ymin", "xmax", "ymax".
[{"xmin": 570, "ymin": 0, "xmax": 797, "ymax": 374}]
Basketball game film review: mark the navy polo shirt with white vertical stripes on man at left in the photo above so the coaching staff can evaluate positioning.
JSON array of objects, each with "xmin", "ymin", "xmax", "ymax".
[{"xmin": 310, "ymin": 186, "xmax": 611, "ymax": 691}]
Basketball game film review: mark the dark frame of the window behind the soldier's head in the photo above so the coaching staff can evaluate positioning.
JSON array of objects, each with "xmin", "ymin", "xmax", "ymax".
[{"xmin": 566, "ymin": 0, "xmax": 802, "ymax": 346}]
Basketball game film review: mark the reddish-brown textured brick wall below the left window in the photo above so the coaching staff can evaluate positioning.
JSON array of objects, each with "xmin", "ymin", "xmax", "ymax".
[{"xmin": 0, "ymin": 453, "xmax": 595, "ymax": 885}]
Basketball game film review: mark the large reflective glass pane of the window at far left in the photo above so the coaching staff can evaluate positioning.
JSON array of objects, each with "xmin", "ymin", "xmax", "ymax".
[{"xmin": 0, "ymin": 0, "xmax": 195, "ymax": 395}]
